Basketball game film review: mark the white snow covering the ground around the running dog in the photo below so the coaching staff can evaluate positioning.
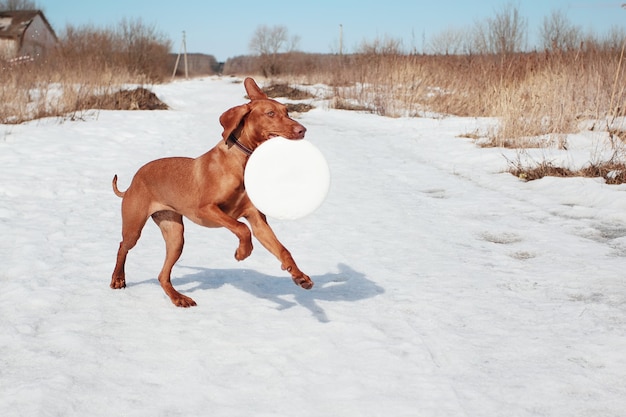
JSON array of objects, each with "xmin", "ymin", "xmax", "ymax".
[{"xmin": 0, "ymin": 78, "xmax": 626, "ymax": 417}]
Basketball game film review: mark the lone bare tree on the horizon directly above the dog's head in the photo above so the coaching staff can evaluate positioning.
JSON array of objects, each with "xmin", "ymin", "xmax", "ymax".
[{"xmin": 248, "ymin": 25, "xmax": 300, "ymax": 76}]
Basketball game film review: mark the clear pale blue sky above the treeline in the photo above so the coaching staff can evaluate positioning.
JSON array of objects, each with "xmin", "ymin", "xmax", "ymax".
[{"xmin": 42, "ymin": 0, "xmax": 626, "ymax": 61}]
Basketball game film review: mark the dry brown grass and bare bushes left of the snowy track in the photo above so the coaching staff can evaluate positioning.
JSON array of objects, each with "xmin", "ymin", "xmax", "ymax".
[{"xmin": 0, "ymin": 21, "xmax": 170, "ymax": 124}]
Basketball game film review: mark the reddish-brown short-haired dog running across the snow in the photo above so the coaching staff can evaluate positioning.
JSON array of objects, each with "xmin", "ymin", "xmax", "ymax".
[{"xmin": 111, "ymin": 78, "xmax": 313, "ymax": 307}]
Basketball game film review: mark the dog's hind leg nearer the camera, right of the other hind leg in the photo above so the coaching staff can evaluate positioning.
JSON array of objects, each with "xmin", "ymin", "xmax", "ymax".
[{"xmin": 152, "ymin": 211, "xmax": 196, "ymax": 307}]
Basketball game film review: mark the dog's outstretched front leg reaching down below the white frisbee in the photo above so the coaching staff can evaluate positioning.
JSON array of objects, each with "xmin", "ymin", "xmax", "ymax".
[{"xmin": 246, "ymin": 211, "xmax": 313, "ymax": 290}]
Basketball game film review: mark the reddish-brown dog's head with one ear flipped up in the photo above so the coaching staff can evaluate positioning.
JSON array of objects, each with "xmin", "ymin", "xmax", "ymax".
[{"xmin": 220, "ymin": 78, "xmax": 306, "ymax": 149}]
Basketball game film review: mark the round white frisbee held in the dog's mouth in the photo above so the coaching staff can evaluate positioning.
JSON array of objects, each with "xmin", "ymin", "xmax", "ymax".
[{"xmin": 244, "ymin": 137, "xmax": 330, "ymax": 220}]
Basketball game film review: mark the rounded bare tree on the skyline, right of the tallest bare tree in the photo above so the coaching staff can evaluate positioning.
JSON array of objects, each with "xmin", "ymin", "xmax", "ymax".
[{"xmin": 539, "ymin": 10, "xmax": 582, "ymax": 51}]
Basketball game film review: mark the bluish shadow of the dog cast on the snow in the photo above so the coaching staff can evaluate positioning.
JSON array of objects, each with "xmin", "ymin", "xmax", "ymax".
[{"xmin": 129, "ymin": 264, "xmax": 384, "ymax": 322}]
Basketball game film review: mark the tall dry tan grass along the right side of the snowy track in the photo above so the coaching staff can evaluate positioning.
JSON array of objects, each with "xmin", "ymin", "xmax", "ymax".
[{"xmin": 226, "ymin": 42, "xmax": 626, "ymax": 183}]
